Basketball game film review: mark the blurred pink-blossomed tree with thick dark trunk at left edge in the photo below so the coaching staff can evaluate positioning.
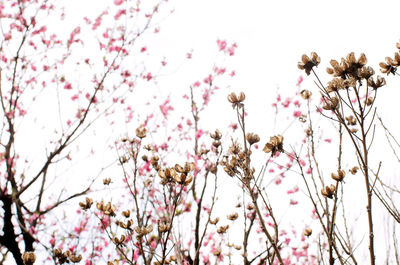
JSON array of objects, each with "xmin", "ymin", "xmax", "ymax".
[{"xmin": 0, "ymin": 0, "xmax": 177, "ymax": 264}]
